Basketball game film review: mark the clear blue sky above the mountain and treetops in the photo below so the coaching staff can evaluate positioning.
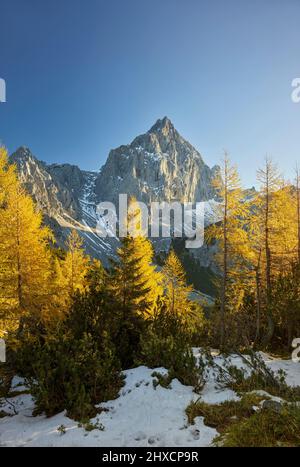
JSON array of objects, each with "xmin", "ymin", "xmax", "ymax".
[{"xmin": 0, "ymin": 0, "xmax": 300, "ymax": 185}]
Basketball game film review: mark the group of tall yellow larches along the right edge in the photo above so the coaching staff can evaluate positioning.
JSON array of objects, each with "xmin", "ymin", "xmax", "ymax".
[{"xmin": 207, "ymin": 154, "xmax": 300, "ymax": 351}]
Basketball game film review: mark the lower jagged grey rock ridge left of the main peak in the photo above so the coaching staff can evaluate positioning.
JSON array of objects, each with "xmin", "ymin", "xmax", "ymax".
[{"xmin": 10, "ymin": 147, "xmax": 118, "ymax": 264}]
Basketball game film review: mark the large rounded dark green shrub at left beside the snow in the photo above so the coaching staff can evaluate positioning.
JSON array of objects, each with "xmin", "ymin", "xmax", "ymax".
[{"xmin": 27, "ymin": 334, "xmax": 122, "ymax": 420}]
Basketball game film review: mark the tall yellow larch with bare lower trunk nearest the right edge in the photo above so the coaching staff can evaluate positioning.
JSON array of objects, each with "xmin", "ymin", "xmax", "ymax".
[{"xmin": 250, "ymin": 157, "xmax": 298, "ymax": 345}]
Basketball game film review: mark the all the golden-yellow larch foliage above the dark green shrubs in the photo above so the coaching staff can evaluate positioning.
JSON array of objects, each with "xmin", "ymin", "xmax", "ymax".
[{"xmin": 0, "ymin": 143, "xmax": 300, "ymax": 354}]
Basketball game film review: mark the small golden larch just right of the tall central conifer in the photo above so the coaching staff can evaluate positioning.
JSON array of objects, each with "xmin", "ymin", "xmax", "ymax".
[{"xmin": 162, "ymin": 249, "xmax": 193, "ymax": 317}]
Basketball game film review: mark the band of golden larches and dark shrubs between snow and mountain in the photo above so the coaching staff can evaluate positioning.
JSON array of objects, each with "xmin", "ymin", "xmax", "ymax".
[{"xmin": 0, "ymin": 148, "xmax": 300, "ymax": 420}]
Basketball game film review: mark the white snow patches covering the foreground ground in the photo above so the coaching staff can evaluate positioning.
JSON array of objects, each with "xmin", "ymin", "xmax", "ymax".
[{"xmin": 0, "ymin": 349, "xmax": 300, "ymax": 447}]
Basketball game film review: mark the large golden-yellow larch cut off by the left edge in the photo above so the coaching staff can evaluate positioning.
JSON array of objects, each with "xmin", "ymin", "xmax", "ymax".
[{"xmin": 0, "ymin": 148, "xmax": 52, "ymax": 331}]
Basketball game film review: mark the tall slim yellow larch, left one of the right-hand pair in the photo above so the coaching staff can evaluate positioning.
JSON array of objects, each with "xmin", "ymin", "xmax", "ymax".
[{"xmin": 207, "ymin": 152, "xmax": 252, "ymax": 348}]
